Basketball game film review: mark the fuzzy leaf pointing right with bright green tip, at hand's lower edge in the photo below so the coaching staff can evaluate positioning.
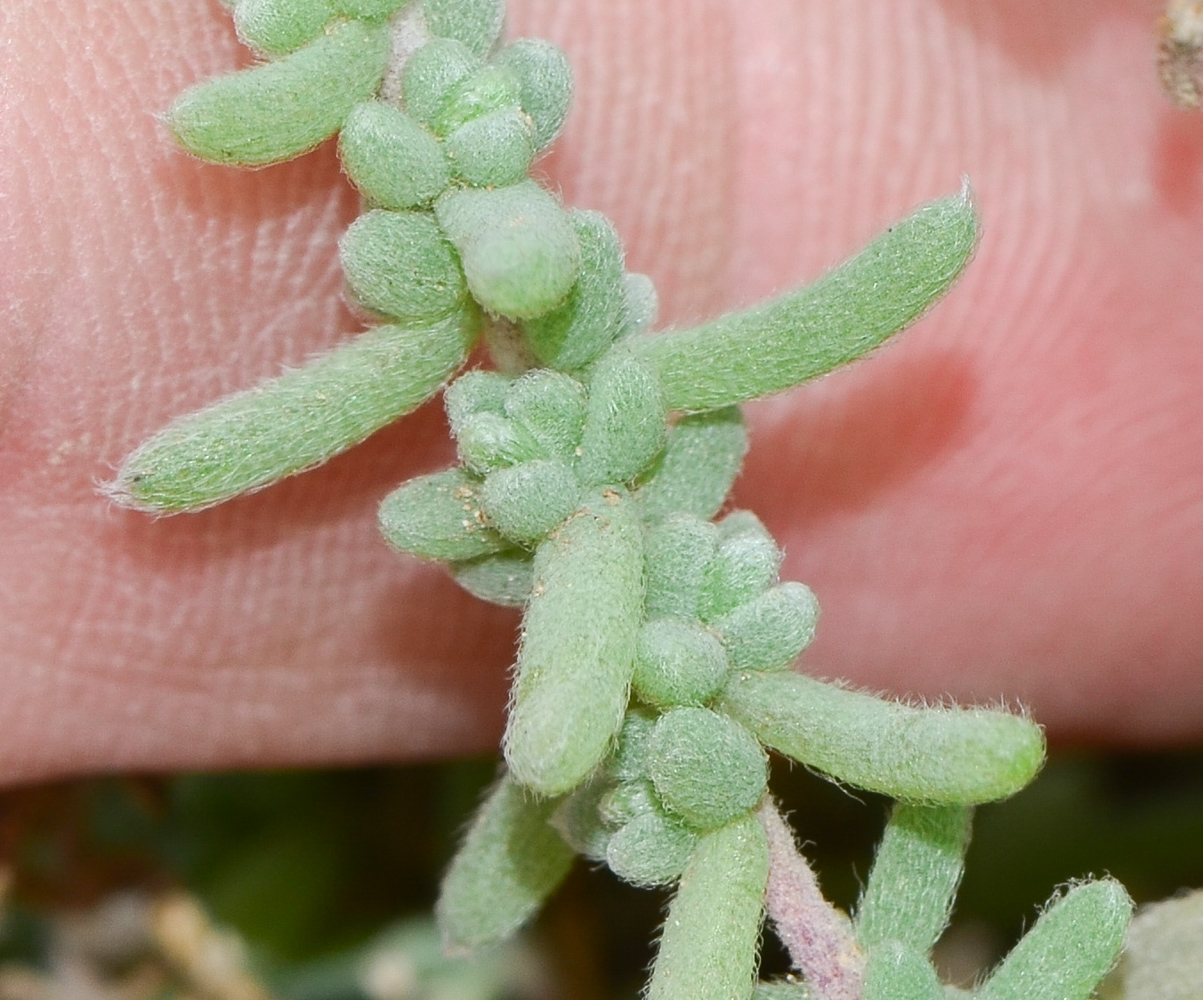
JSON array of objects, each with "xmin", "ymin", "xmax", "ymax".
[{"xmin": 721, "ymin": 671, "xmax": 1044, "ymax": 805}]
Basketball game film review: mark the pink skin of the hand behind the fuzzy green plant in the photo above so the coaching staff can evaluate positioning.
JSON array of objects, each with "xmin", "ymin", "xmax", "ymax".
[{"xmin": 0, "ymin": 0, "xmax": 1203, "ymax": 781}]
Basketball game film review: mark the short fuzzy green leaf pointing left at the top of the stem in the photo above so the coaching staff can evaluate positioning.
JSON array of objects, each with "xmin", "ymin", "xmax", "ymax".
[{"xmin": 167, "ymin": 20, "xmax": 390, "ymax": 166}]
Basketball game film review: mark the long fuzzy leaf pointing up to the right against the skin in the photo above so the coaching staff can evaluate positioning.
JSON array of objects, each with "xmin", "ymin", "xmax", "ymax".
[{"xmin": 636, "ymin": 193, "xmax": 978, "ymax": 410}]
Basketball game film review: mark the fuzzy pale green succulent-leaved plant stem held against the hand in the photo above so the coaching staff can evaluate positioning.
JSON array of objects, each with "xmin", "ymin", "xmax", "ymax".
[{"xmin": 109, "ymin": 0, "xmax": 1131, "ymax": 1000}]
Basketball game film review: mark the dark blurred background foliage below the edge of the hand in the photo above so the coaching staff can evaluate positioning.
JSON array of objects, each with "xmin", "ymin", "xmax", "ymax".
[{"xmin": 0, "ymin": 752, "xmax": 1203, "ymax": 1000}]
